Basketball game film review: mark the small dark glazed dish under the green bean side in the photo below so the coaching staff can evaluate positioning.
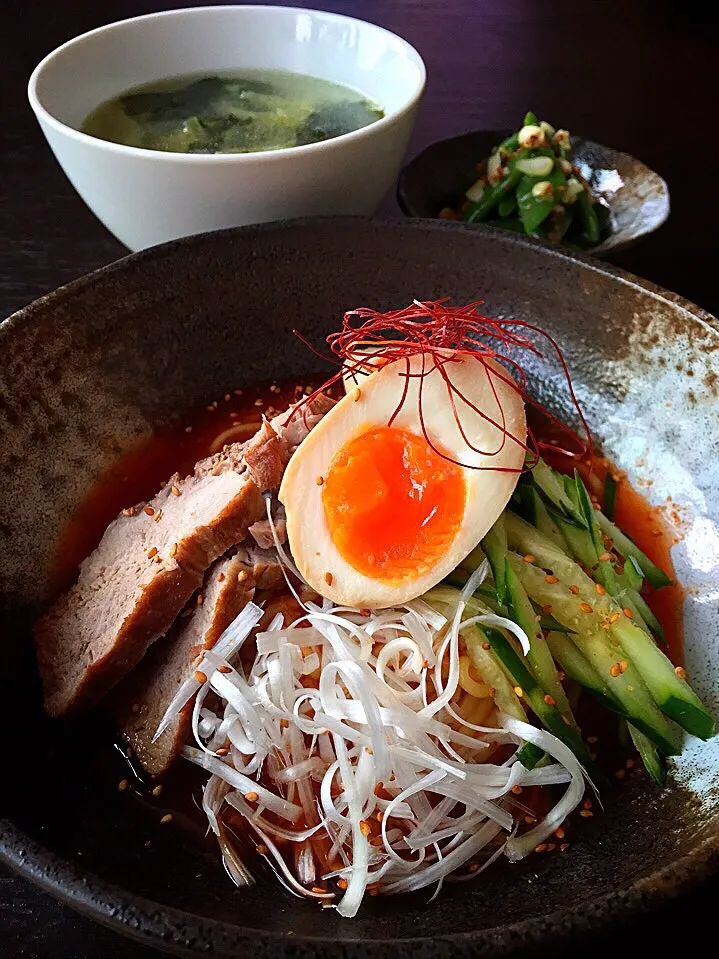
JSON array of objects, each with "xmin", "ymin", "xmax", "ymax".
[{"xmin": 397, "ymin": 130, "xmax": 669, "ymax": 256}]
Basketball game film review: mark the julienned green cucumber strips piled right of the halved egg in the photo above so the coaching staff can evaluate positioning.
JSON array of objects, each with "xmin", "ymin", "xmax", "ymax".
[{"xmin": 438, "ymin": 460, "xmax": 714, "ymax": 784}]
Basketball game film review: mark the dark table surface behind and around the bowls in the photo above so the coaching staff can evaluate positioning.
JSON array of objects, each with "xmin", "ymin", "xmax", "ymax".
[{"xmin": 0, "ymin": 0, "xmax": 719, "ymax": 959}]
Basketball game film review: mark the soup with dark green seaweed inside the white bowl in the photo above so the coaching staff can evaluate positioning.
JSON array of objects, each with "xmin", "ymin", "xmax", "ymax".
[{"xmin": 82, "ymin": 70, "xmax": 384, "ymax": 153}]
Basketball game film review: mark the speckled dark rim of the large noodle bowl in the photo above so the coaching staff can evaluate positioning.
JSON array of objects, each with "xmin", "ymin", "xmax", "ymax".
[{"xmin": 0, "ymin": 216, "xmax": 719, "ymax": 959}]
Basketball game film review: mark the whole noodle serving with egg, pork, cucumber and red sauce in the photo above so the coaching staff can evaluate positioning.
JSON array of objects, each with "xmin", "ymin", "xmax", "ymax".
[{"xmin": 36, "ymin": 302, "xmax": 713, "ymax": 916}]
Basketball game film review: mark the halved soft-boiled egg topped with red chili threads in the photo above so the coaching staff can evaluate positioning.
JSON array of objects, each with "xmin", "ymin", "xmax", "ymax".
[{"xmin": 279, "ymin": 352, "xmax": 527, "ymax": 609}]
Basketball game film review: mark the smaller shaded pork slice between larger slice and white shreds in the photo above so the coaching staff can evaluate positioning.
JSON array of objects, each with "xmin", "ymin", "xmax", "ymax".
[{"xmin": 112, "ymin": 547, "xmax": 283, "ymax": 776}]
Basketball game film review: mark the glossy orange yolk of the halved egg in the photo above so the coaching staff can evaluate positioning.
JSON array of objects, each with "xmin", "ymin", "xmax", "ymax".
[{"xmin": 322, "ymin": 426, "xmax": 466, "ymax": 583}]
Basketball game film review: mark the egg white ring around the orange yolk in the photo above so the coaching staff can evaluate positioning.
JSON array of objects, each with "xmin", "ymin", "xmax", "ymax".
[{"xmin": 279, "ymin": 353, "xmax": 527, "ymax": 609}]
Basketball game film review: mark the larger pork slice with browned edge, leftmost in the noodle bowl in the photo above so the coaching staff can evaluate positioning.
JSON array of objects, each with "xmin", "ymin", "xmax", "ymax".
[{"xmin": 35, "ymin": 397, "xmax": 333, "ymax": 716}]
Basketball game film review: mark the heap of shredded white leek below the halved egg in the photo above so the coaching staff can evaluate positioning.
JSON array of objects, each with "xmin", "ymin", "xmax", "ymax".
[{"xmin": 174, "ymin": 568, "xmax": 585, "ymax": 916}]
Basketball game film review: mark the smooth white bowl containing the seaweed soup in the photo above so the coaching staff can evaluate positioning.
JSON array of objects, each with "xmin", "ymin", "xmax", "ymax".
[{"xmin": 28, "ymin": 6, "xmax": 425, "ymax": 250}]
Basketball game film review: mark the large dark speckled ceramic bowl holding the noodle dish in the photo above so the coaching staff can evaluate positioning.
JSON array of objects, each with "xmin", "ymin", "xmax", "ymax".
[{"xmin": 0, "ymin": 218, "xmax": 719, "ymax": 959}]
